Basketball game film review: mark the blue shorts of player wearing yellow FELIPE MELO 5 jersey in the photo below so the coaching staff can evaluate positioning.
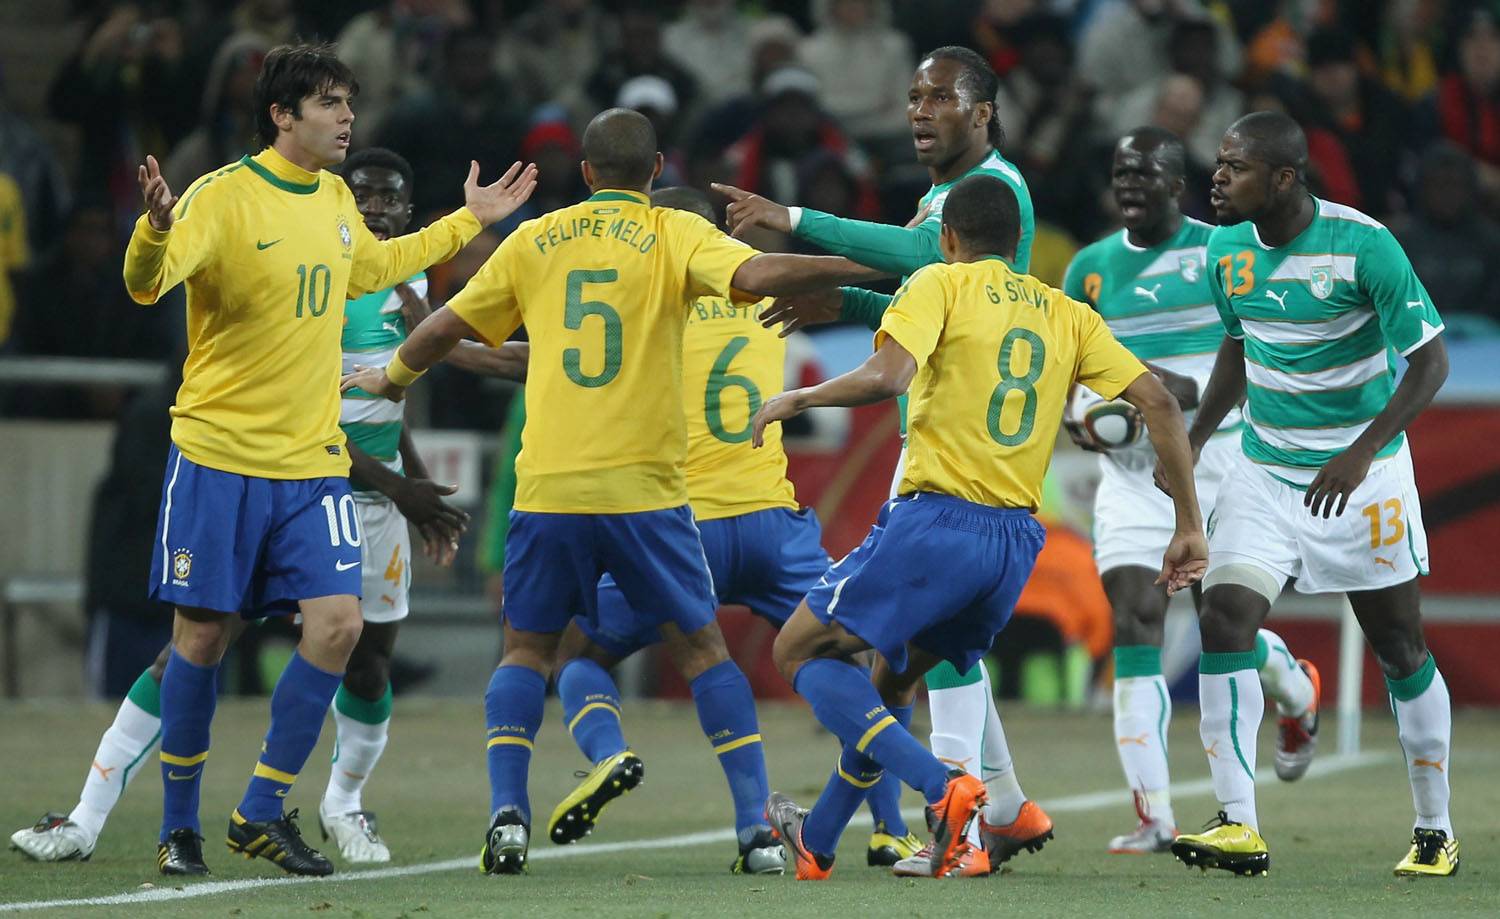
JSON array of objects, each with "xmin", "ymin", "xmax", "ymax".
[{"xmin": 503, "ymin": 504, "xmax": 719, "ymax": 633}]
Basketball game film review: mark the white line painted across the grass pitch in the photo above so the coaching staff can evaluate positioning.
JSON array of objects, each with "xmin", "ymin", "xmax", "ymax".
[{"xmin": 0, "ymin": 753, "xmax": 1394, "ymax": 913}]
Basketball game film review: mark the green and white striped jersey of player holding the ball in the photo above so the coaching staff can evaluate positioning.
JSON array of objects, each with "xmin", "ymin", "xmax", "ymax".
[{"xmin": 1062, "ymin": 217, "xmax": 1241, "ymax": 430}]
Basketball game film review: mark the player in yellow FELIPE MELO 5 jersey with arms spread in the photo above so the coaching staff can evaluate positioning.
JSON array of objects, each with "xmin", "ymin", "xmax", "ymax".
[{"xmin": 344, "ymin": 109, "xmax": 876, "ymax": 874}]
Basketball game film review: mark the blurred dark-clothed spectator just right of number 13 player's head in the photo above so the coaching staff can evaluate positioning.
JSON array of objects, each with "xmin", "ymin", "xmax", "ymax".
[{"xmin": 1308, "ymin": 30, "xmax": 1407, "ymax": 219}]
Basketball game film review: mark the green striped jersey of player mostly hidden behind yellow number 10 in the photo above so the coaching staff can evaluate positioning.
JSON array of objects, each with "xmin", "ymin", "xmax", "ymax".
[{"xmin": 339, "ymin": 271, "xmax": 428, "ymax": 492}]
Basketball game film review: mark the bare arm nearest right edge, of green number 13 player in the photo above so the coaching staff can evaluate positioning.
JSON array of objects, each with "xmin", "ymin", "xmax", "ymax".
[{"xmin": 1302, "ymin": 334, "xmax": 1448, "ymax": 519}]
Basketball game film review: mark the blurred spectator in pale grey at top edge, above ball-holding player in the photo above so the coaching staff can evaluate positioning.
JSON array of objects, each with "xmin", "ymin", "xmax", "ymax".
[{"xmin": 1079, "ymin": 0, "xmax": 1242, "ymax": 118}]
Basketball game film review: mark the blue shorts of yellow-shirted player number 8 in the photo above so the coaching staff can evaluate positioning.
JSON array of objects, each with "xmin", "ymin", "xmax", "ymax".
[{"xmin": 807, "ymin": 492, "xmax": 1047, "ymax": 673}]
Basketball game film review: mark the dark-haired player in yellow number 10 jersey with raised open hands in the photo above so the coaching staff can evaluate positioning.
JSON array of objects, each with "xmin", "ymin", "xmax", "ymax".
[{"xmin": 125, "ymin": 46, "xmax": 536, "ymax": 874}]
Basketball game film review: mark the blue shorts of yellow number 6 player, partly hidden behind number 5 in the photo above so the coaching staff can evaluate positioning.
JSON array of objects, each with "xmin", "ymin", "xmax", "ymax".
[{"xmin": 579, "ymin": 507, "xmax": 828, "ymax": 660}]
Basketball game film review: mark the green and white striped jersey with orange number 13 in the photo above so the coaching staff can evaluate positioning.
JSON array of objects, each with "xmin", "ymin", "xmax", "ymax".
[{"xmin": 1208, "ymin": 199, "xmax": 1443, "ymax": 486}]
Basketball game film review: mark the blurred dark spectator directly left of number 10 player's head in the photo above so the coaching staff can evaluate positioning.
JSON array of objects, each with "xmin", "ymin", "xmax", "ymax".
[{"xmin": 162, "ymin": 31, "xmax": 272, "ymax": 190}]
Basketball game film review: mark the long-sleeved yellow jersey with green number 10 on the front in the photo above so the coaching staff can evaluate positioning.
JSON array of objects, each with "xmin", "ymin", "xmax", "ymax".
[{"xmin": 125, "ymin": 147, "xmax": 480, "ymax": 478}]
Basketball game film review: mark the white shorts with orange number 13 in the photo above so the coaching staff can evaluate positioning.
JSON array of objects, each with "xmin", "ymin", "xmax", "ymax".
[{"xmin": 1208, "ymin": 444, "xmax": 1427, "ymax": 594}]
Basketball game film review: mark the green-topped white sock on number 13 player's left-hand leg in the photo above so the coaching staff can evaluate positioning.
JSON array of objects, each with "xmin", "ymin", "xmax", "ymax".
[{"xmin": 1199, "ymin": 651, "xmax": 1266, "ymax": 829}]
